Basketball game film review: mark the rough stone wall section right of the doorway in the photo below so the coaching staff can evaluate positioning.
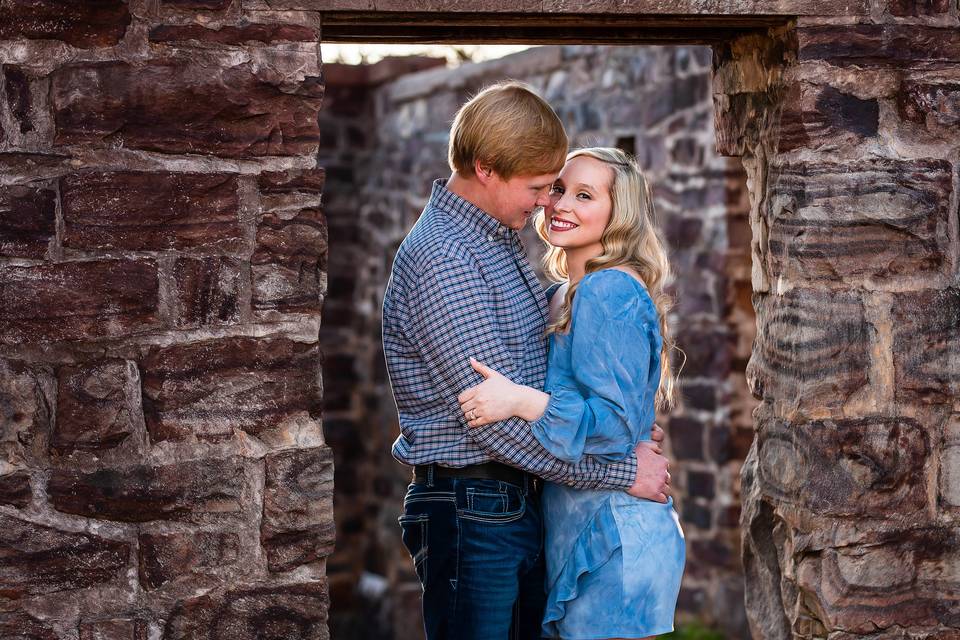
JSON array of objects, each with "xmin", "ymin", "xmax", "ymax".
[{"xmin": 714, "ymin": 7, "xmax": 960, "ymax": 640}]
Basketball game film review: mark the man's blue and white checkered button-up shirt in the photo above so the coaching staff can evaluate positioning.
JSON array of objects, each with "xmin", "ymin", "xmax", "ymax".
[{"xmin": 383, "ymin": 180, "xmax": 637, "ymax": 489}]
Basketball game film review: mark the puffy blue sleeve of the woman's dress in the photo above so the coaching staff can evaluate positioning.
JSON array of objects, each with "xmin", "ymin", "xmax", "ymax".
[{"xmin": 530, "ymin": 273, "xmax": 659, "ymax": 463}]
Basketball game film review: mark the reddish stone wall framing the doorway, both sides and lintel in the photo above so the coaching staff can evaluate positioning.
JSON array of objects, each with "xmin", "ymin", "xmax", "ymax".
[{"xmin": 0, "ymin": 0, "xmax": 960, "ymax": 639}]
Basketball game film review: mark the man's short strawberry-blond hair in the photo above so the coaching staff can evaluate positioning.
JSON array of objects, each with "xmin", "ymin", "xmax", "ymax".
[{"xmin": 448, "ymin": 81, "xmax": 567, "ymax": 180}]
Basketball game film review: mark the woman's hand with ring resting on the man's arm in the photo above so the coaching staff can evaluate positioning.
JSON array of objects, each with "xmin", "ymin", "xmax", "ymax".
[{"xmin": 457, "ymin": 358, "xmax": 549, "ymax": 427}]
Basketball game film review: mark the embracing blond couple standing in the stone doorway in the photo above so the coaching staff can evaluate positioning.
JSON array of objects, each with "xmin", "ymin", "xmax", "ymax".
[{"xmin": 383, "ymin": 83, "xmax": 684, "ymax": 640}]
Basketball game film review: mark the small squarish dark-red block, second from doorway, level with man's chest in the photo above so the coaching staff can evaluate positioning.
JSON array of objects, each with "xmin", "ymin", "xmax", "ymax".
[{"xmin": 173, "ymin": 257, "xmax": 243, "ymax": 327}]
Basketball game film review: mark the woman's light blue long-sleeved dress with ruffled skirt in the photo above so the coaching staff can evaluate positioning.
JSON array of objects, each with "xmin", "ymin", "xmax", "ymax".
[{"xmin": 531, "ymin": 269, "xmax": 685, "ymax": 640}]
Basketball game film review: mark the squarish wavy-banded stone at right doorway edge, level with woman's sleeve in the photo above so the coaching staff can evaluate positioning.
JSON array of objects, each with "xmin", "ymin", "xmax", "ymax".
[{"xmin": 747, "ymin": 289, "xmax": 871, "ymax": 413}]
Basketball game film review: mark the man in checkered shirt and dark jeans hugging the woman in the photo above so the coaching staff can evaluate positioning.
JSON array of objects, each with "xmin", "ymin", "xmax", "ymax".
[{"xmin": 383, "ymin": 83, "xmax": 669, "ymax": 640}]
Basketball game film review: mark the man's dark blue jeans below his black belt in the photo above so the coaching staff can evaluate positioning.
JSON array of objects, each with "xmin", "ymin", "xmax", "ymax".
[{"xmin": 400, "ymin": 470, "xmax": 546, "ymax": 640}]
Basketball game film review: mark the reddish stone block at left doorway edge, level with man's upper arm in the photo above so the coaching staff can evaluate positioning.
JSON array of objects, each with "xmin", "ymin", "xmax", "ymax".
[{"xmin": 251, "ymin": 209, "xmax": 327, "ymax": 312}]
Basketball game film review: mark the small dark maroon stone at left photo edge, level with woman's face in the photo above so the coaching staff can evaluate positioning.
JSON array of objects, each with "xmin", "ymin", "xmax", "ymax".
[{"xmin": 0, "ymin": 185, "xmax": 57, "ymax": 258}]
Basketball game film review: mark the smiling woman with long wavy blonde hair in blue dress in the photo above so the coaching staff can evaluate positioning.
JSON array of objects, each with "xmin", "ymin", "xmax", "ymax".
[{"xmin": 460, "ymin": 148, "xmax": 684, "ymax": 640}]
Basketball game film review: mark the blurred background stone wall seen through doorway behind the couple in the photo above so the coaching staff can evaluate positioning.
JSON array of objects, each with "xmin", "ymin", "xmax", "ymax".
[{"xmin": 320, "ymin": 46, "xmax": 755, "ymax": 638}]
